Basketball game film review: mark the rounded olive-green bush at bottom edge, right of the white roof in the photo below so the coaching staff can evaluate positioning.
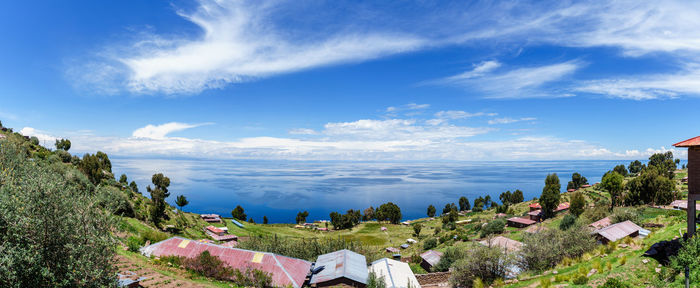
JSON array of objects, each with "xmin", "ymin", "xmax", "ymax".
[{"xmin": 450, "ymin": 245, "xmax": 513, "ymax": 287}]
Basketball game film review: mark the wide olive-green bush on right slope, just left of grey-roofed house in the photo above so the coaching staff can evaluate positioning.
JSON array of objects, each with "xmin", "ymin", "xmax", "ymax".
[{"xmin": 519, "ymin": 226, "xmax": 596, "ymax": 271}]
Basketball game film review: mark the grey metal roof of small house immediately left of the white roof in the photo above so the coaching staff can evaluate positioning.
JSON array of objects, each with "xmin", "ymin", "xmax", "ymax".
[{"xmin": 309, "ymin": 249, "xmax": 369, "ymax": 287}]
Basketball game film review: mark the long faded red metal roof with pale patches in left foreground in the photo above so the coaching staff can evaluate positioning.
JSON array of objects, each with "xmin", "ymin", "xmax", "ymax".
[{"xmin": 141, "ymin": 237, "xmax": 311, "ymax": 288}]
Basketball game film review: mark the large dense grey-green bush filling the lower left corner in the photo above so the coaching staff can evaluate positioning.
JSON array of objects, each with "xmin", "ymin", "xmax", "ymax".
[{"xmin": 0, "ymin": 142, "xmax": 116, "ymax": 287}]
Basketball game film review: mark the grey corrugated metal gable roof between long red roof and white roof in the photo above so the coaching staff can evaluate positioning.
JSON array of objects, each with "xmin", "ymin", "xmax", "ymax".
[{"xmin": 311, "ymin": 249, "xmax": 368, "ymax": 284}]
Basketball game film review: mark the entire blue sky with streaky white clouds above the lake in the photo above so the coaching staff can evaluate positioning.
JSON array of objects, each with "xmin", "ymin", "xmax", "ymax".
[{"xmin": 0, "ymin": 0, "xmax": 700, "ymax": 161}]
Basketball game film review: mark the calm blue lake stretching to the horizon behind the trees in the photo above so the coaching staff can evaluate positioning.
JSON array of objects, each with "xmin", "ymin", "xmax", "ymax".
[{"xmin": 112, "ymin": 158, "xmax": 684, "ymax": 223}]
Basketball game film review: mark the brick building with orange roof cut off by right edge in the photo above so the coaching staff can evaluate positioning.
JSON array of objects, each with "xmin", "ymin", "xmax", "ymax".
[{"xmin": 673, "ymin": 136, "xmax": 700, "ymax": 238}]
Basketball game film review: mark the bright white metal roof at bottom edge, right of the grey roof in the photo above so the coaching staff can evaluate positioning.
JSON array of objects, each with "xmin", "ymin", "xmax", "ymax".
[{"xmin": 369, "ymin": 258, "xmax": 420, "ymax": 288}]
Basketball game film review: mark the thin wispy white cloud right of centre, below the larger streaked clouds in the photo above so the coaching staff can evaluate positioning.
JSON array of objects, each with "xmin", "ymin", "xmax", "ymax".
[{"xmin": 433, "ymin": 61, "xmax": 583, "ymax": 98}]
